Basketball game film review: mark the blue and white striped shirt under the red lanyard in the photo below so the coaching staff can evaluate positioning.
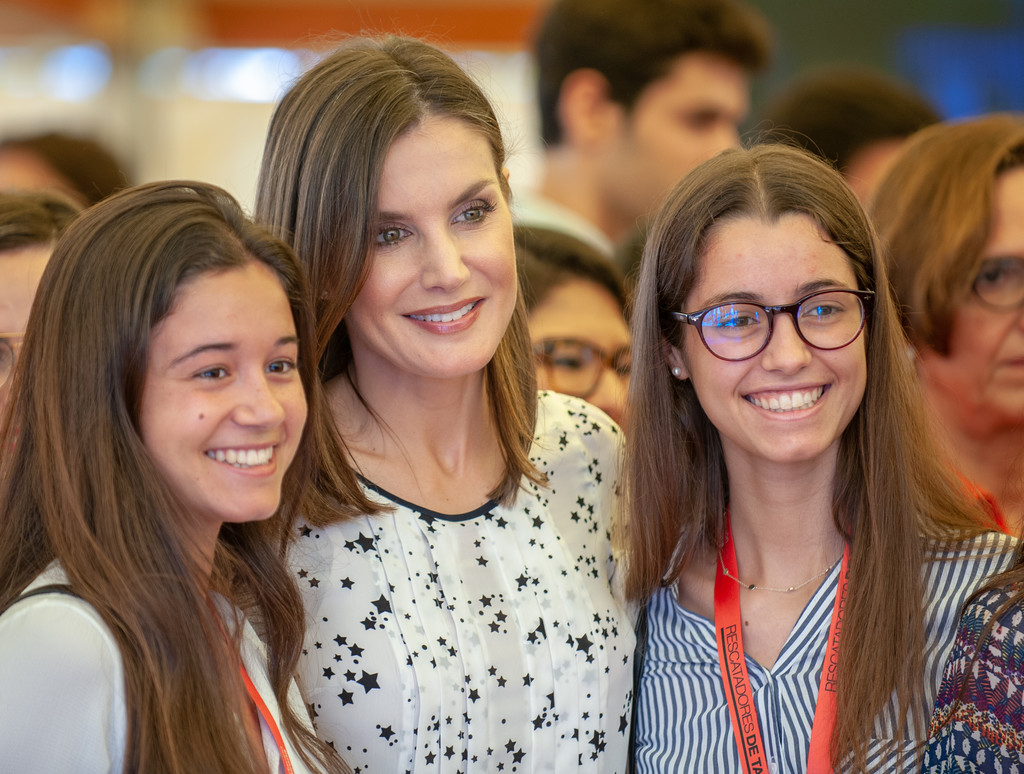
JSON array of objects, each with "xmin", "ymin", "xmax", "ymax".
[{"xmin": 636, "ymin": 532, "xmax": 1015, "ymax": 774}]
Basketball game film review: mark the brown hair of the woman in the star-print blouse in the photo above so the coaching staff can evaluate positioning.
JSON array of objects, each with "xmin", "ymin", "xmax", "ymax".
[{"xmin": 255, "ymin": 36, "xmax": 539, "ymax": 511}]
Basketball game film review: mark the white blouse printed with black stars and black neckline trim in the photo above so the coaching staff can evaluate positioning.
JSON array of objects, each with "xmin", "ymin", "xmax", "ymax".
[{"xmin": 291, "ymin": 393, "xmax": 634, "ymax": 774}]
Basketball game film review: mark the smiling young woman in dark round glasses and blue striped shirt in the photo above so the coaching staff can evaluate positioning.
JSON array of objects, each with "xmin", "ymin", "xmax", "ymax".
[{"xmin": 626, "ymin": 145, "xmax": 1012, "ymax": 774}]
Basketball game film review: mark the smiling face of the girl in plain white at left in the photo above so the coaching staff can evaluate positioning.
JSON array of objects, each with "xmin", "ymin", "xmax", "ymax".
[{"xmin": 138, "ymin": 261, "xmax": 306, "ymax": 556}]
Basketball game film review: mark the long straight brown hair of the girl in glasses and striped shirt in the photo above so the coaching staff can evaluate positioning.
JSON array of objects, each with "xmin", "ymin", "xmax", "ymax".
[{"xmin": 625, "ymin": 145, "xmax": 991, "ymax": 770}]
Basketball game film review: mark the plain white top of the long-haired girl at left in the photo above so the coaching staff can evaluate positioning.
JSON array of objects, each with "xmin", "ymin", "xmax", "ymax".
[{"xmin": 0, "ymin": 564, "xmax": 317, "ymax": 774}]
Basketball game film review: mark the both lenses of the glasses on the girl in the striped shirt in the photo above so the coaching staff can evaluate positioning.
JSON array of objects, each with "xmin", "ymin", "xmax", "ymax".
[{"xmin": 700, "ymin": 291, "xmax": 864, "ymax": 360}]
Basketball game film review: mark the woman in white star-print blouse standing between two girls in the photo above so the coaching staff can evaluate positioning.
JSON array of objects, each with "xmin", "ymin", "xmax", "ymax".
[{"xmin": 256, "ymin": 38, "xmax": 634, "ymax": 774}]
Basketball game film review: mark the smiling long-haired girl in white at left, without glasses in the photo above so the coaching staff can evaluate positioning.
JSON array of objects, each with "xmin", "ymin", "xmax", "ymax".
[{"xmin": 0, "ymin": 182, "xmax": 347, "ymax": 774}]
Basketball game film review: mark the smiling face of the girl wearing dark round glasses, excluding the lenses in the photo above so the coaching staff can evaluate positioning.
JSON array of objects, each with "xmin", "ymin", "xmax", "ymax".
[{"xmin": 669, "ymin": 214, "xmax": 867, "ymax": 475}]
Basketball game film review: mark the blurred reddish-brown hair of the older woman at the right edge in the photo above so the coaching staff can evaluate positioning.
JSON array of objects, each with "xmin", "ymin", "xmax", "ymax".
[{"xmin": 870, "ymin": 113, "xmax": 1024, "ymax": 354}]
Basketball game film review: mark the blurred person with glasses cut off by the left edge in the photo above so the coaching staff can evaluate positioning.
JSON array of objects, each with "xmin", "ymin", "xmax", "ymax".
[{"xmin": 0, "ymin": 191, "xmax": 80, "ymax": 411}]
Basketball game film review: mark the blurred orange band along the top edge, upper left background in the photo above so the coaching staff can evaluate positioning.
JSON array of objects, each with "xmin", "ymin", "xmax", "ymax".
[{"xmin": 0, "ymin": 0, "xmax": 547, "ymax": 51}]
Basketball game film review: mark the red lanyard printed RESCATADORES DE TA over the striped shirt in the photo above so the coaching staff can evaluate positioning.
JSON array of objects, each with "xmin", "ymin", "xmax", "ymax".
[{"xmin": 715, "ymin": 520, "xmax": 850, "ymax": 774}]
